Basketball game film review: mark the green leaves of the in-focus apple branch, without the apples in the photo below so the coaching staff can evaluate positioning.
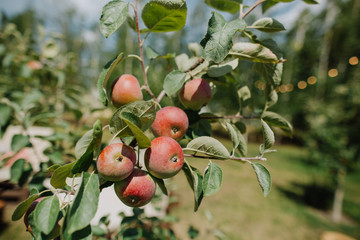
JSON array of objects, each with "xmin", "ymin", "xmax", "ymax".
[{"xmin": 3, "ymin": 0, "xmax": 320, "ymax": 239}]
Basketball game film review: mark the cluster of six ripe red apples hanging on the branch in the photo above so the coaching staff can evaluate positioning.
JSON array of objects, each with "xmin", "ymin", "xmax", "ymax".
[{"xmin": 97, "ymin": 74, "xmax": 211, "ymax": 207}]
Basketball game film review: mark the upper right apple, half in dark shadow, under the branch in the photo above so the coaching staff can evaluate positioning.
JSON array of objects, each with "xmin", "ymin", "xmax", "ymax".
[{"xmin": 179, "ymin": 78, "xmax": 211, "ymax": 110}]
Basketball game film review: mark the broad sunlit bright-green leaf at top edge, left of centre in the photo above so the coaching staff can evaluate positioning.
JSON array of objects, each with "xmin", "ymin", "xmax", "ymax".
[{"xmin": 141, "ymin": 0, "xmax": 187, "ymax": 32}]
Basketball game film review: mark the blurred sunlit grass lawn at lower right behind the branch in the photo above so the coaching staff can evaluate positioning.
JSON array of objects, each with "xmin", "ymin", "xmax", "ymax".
[{"xmin": 172, "ymin": 140, "xmax": 360, "ymax": 240}]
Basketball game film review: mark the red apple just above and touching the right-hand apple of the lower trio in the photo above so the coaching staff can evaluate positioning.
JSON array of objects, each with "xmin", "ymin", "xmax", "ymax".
[{"xmin": 151, "ymin": 106, "xmax": 189, "ymax": 141}]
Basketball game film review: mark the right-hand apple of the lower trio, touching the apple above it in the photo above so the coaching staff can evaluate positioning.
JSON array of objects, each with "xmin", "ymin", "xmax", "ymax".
[{"xmin": 144, "ymin": 137, "xmax": 184, "ymax": 178}]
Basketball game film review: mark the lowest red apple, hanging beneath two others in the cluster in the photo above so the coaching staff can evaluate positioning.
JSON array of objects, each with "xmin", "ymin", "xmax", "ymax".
[{"xmin": 114, "ymin": 168, "xmax": 156, "ymax": 207}]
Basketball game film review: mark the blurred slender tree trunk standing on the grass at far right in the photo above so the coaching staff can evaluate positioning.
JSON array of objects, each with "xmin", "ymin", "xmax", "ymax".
[{"xmin": 332, "ymin": 169, "xmax": 346, "ymax": 222}]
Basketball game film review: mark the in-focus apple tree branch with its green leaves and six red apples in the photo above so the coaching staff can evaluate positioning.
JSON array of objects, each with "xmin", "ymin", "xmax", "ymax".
[{"xmin": 12, "ymin": 0, "xmax": 318, "ymax": 239}]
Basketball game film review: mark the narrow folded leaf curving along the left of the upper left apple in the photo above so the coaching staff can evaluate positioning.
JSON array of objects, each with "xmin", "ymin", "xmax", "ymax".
[{"xmin": 97, "ymin": 53, "xmax": 124, "ymax": 106}]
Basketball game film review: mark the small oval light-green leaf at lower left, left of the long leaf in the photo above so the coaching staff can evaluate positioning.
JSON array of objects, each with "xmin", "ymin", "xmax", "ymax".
[{"xmin": 34, "ymin": 195, "xmax": 60, "ymax": 235}]
